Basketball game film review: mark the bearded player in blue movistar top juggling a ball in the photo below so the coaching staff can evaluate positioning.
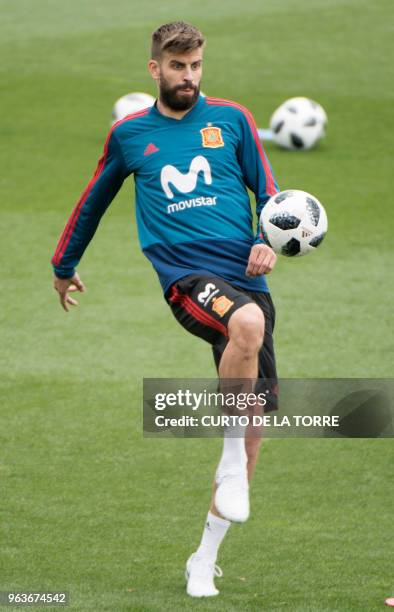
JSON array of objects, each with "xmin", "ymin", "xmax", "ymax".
[{"xmin": 52, "ymin": 22, "xmax": 278, "ymax": 597}]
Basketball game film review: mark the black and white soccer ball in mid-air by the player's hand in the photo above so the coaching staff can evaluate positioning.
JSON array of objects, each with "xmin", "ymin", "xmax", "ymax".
[{"xmin": 260, "ymin": 189, "xmax": 328, "ymax": 257}]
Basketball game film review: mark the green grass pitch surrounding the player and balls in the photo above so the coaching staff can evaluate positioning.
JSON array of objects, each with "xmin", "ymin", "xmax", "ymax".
[{"xmin": 0, "ymin": 0, "xmax": 394, "ymax": 612}]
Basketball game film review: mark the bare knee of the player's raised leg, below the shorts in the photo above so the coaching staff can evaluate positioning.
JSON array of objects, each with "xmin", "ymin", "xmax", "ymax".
[{"xmin": 228, "ymin": 304, "xmax": 264, "ymax": 359}]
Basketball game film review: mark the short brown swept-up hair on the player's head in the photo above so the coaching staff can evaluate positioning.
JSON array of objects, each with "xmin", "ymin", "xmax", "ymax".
[{"xmin": 151, "ymin": 21, "xmax": 205, "ymax": 60}]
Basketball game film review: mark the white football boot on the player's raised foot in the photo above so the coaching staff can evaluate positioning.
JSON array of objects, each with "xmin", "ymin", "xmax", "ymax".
[{"xmin": 215, "ymin": 467, "xmax": 250, "ymax": 523}]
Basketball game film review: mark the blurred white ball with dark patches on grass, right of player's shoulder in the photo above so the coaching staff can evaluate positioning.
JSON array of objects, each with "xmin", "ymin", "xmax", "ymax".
[{"xmin": 270, "ymin": 97, "xmax": 327, "ymax": 151}]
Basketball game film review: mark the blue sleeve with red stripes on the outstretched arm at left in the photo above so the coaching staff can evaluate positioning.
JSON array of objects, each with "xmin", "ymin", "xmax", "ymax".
[{"xmin": 52, "ymin": 130, "xmax": 129, "ymax": 278}]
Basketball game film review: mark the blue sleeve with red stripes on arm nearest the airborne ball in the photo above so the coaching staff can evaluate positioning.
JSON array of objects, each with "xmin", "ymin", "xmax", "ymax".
[{"xmin": 237, "ymin": 108, "xmax": 279, "ymax": 244}]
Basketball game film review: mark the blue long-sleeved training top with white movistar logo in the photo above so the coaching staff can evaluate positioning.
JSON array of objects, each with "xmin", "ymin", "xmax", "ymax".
[{"xmin": 52, "ymin": 95, "xmax": 278, "ymax": 293}]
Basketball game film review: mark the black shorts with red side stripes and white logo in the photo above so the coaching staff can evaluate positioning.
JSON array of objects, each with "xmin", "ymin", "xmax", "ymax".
[{"xmin": 166, "ymin": 274, "xmax": 278, "ymax": 412}]
